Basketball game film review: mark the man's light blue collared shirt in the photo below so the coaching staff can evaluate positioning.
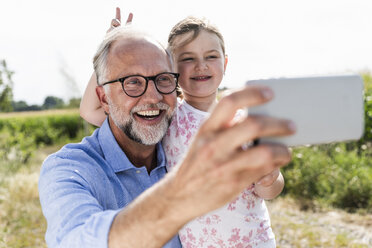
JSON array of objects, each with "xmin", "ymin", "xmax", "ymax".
[{"xmin": 39, "ymin": 120, "xmax": 181, "ymax": 248}]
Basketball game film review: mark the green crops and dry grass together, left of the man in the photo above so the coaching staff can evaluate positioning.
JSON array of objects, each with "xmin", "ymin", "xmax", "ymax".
[{"xmin": 0, "ymin": 109, "xmax": 94, "ymax": 248}]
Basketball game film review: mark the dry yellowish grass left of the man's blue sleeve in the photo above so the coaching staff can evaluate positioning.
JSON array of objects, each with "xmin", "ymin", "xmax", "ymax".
[{"xmin": 0, "ymin": 148, "xmax": 57, "ymax": 248}]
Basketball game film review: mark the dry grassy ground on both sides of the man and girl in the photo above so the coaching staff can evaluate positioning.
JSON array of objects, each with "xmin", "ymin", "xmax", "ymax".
[{"xmin": 0, "ymin": 147, "xmax": 372, "ymax": 248}]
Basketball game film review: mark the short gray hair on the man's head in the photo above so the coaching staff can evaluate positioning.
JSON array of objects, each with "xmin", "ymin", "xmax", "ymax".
[{"xmin": 93, "ymin": 25, "xmax": 173, "ymax": 85}]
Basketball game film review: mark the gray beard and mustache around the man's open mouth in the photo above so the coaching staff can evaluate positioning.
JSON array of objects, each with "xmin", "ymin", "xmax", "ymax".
[{"xmin": 109, "ymin": 102, "xmax": 173, "ymax": 145}]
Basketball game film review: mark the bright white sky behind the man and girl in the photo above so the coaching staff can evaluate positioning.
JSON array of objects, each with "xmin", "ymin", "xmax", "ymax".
[{"xmin": 0, "ymin": 0, "xmax": 372, "ymax": 104}]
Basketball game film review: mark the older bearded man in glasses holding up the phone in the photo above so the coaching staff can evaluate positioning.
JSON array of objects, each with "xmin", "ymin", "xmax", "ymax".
[{"xmin": 39, "ymin": 28, "xmax": 293, "ymax": 248}]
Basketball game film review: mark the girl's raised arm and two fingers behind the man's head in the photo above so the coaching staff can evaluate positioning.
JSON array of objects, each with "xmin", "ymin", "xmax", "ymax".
[{"xmin": 80, "ymin": 8, "xmax": 133, "ymax": 126}]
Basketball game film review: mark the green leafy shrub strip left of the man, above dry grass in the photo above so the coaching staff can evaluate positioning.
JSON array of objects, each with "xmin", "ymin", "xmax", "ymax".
[{"xmin": 0, "ymin": 112, "xmax": 94, "ymax": 172}]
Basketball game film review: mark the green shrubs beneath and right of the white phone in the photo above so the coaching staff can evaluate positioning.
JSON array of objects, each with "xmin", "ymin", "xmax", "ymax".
[{"xmin": 283, "ymin": 73, "xmax": 372, "ymax": 212}]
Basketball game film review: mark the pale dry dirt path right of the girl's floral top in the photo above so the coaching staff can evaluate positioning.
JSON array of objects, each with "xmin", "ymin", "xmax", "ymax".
[{"xmin": 267, "ymin": 198, "xmax": 372, "ymax": 248}]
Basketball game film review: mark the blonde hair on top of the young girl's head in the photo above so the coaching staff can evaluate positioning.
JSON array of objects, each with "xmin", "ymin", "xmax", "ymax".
[{"xmin": 168, "ymin": 16, "xmax": 225, "ymax": 55}]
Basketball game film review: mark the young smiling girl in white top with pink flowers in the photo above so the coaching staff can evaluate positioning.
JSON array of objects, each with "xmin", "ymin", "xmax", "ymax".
[{"xmin": 81, "ymin": 8, "xmax": 284, "ymax": 248}]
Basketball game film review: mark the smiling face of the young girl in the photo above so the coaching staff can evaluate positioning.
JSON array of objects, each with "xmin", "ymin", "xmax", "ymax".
[{"xmin": 174, "ymin": 30, "xmax": 227, "ymax": 100}]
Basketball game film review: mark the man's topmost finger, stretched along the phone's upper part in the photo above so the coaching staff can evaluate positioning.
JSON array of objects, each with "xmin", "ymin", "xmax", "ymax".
[{"xmin": 202, "ymin": 86, "xmax": 274, "ymax": 131}]
